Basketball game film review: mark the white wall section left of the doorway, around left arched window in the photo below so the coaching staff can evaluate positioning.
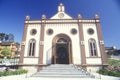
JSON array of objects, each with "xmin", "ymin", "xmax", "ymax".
[{"xmin": 23, "ymin": 24, "xmax": 41, "ymax": 64}]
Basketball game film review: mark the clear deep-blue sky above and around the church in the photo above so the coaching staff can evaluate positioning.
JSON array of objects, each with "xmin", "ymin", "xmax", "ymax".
[{"xmin": 0, "ymin": 0, "xmax": 120, "ymax": 49}]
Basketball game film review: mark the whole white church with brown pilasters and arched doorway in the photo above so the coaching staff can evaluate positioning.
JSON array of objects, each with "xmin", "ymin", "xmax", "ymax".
[{"xmin": 19, "ymin": 3, "xmax": 107, "ymax": 71}]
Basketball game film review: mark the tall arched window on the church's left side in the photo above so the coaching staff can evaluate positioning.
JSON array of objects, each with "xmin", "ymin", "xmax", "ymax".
[{"xmin": 28, "ymin": 39, "xmax": 36, "ymax": 56}]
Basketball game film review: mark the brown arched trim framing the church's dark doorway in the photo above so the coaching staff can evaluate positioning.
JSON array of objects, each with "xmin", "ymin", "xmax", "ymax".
[{"xmin": 52, "ymin": 34, "xmax": 73, "ymax": 64}]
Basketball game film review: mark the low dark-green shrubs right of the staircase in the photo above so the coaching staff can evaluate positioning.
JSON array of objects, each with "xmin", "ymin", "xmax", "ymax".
[{"xmin": 99, "ymin": 69, "xmax": 120, "ymax": 77}]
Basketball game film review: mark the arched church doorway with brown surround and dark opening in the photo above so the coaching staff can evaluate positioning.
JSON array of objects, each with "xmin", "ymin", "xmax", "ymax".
[{"xmin": 52, "ymin": 34, "xmax": 72, "ymax": 64}]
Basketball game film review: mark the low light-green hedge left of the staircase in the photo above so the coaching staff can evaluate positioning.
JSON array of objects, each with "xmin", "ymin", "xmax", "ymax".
[{"xmin": 0, "ymin": 69, "xmax": 27, "ymax": 76}]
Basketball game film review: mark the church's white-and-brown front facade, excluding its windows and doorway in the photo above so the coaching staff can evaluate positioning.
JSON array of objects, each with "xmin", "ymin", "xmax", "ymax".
[{"xmin": 20, "ymin": 4, "xmax": 106, "ymax": 71}]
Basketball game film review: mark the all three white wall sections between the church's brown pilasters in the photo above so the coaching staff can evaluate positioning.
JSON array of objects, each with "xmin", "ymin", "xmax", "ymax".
[{"xmin": 21, "ymin": 23, "xmax": 102, "ymax": 64}]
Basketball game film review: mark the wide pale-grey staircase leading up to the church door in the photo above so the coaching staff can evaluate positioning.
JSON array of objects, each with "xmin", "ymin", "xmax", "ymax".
[{"xmin": 32, "ymin": 64, "xmax": 95, "ymax": 79}]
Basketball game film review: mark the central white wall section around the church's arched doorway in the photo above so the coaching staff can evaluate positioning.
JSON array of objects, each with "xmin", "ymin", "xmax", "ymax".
[{"xmin": 43, "ymin": 24, "xmax": 81, "ymax": 64}]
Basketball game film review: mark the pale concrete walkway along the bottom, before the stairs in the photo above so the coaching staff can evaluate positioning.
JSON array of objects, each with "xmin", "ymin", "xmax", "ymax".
[{"xmin": 0, "ymin": 73, "xmax": 120, "ymax": 80}]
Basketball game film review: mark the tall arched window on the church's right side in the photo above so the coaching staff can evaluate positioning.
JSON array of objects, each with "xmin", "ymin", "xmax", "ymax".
[{"xmin": 89, "ymin": 39, "xmax": 97, "ymax": 57}]
